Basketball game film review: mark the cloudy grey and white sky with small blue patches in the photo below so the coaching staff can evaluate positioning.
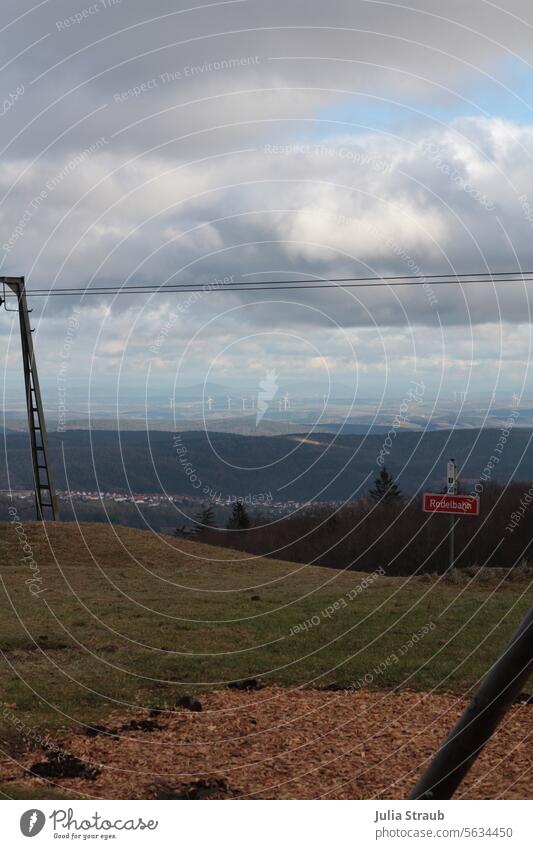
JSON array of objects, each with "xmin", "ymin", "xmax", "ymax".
[{"xmin": 0, "ymin": 0, "xmax": 533, "ymax": 406}]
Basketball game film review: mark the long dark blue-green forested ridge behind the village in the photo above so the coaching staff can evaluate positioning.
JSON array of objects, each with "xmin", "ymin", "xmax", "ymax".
[{"xmin": 0, "ymin": 427, "xmax": 533, "ymax": 501}]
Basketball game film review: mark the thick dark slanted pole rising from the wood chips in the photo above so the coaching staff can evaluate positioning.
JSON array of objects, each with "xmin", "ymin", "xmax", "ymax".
[{"xmin": 409, "ymin": 607, "xmax": 533, "ymax": 799}]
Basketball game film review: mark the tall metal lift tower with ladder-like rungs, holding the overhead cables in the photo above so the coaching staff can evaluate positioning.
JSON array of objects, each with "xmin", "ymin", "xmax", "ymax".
[{"xmin": 0, "ymin": 277, "xmax": 57, "ymax": 520}]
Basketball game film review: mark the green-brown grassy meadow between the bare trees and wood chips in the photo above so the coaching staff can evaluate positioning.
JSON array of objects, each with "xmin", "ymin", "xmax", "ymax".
[{"xmin": 0, "ymin": 523, "xmax": 531, "ymax": 750}]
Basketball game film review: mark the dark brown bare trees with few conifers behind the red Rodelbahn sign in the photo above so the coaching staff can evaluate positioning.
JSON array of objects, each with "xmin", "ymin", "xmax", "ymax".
[{"xmin": 182, "ymin": 468, "xmax": 533, "ymax": 575}]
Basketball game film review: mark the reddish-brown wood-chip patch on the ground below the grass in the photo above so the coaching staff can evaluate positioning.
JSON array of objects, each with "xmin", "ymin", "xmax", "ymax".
[{"xmin": 0, "ymin": 688, "xmax": 533, "ymax": 799}]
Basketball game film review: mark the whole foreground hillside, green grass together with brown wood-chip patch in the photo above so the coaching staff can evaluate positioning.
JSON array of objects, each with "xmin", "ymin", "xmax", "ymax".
[{"xmin": 0, "ymin": 523, "xmax": 533, "ymax": 798}]
